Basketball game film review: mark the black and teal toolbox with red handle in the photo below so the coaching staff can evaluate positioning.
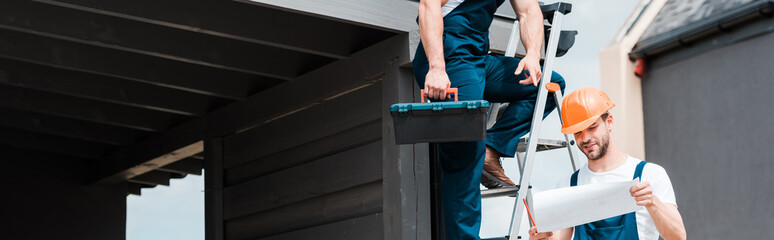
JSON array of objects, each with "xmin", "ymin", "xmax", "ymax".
[{"xmin": 390, "ymin": 88, "xmax": 489, "ymax": 144}]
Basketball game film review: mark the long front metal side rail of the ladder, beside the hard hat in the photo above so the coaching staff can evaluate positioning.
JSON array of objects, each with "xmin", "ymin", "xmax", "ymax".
[{"xmin": 508, "ymin": 11, "xmax": 564, "ymax": 236}]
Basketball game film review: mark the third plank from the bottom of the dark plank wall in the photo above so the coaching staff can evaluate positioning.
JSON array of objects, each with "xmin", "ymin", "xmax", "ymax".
[{"xmin": 224, "ymin": 141, "xmax": 382, "ymax": 219}]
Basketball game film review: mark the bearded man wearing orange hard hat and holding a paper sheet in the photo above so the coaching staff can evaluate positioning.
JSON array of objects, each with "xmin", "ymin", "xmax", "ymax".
[{"xmin": 529, "ymin": 87, "xmax": 686, "ymax": 240}]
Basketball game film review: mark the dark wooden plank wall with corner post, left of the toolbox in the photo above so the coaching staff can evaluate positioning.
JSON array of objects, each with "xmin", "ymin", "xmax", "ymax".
[{"xmin": 205, "ymin": 34, "xmax": 431, "ymax": 240}]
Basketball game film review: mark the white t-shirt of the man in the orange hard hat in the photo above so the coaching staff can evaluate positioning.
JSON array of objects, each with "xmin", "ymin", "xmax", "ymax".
[{"xmin": 556, "ymin": 156, "xmax": 677, "ymax": 240}]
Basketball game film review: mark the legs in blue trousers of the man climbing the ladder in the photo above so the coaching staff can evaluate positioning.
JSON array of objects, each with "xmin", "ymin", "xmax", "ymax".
[{"xmin": 418, "ymin": 55, "xmax": 564, "ymax": 239}]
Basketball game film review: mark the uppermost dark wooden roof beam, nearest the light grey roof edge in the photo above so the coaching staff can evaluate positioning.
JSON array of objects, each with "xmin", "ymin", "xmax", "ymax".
[{"xmin": 37, "ymin": 0, "xmax": 394, "ymax": 59}]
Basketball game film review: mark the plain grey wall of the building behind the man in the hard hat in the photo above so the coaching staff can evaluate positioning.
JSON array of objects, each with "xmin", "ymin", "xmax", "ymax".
[{"xmin": 642, "ymin": 32, "xmax": 774, "ymax": 239}]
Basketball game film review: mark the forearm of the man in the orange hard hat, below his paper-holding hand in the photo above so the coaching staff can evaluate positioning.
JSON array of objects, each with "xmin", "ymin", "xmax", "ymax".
[{"xmin": 647, "ymin": 196, "xmax": 686, "ymax": 240}]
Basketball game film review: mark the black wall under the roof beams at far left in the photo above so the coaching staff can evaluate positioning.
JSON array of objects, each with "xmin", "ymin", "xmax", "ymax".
[{"xmin": 0, "ymin": 147, "xmax": 127, "ymax": 239}]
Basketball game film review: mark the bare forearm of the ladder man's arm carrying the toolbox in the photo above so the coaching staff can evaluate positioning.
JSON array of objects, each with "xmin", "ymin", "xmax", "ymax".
[{"xmin": 419, "ymin": 0, "xmax": 446, "ymax": 70}]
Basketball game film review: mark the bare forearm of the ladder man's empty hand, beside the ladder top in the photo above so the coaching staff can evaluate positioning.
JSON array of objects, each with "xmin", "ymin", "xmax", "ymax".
[{"xmin": 511, "ymin": 0, "xmax": 543, "ymax": 57}]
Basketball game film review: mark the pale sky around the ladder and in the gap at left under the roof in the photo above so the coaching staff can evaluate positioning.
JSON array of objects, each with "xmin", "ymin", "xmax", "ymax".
[{"xmin": 126, "ymin": 0, "xmax": 639, "ymax": 240}]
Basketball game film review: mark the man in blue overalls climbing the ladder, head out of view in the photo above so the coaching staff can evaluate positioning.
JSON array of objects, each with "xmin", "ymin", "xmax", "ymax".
[{"xmin": 413, "ymin": 0, "xmax": 564, "ymax": 239}]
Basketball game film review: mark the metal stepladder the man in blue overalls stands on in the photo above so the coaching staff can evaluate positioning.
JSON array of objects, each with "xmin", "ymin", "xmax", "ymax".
[{"xmin": 481, "ymin": 2, "xmax": 577, "ymax": 240}]
